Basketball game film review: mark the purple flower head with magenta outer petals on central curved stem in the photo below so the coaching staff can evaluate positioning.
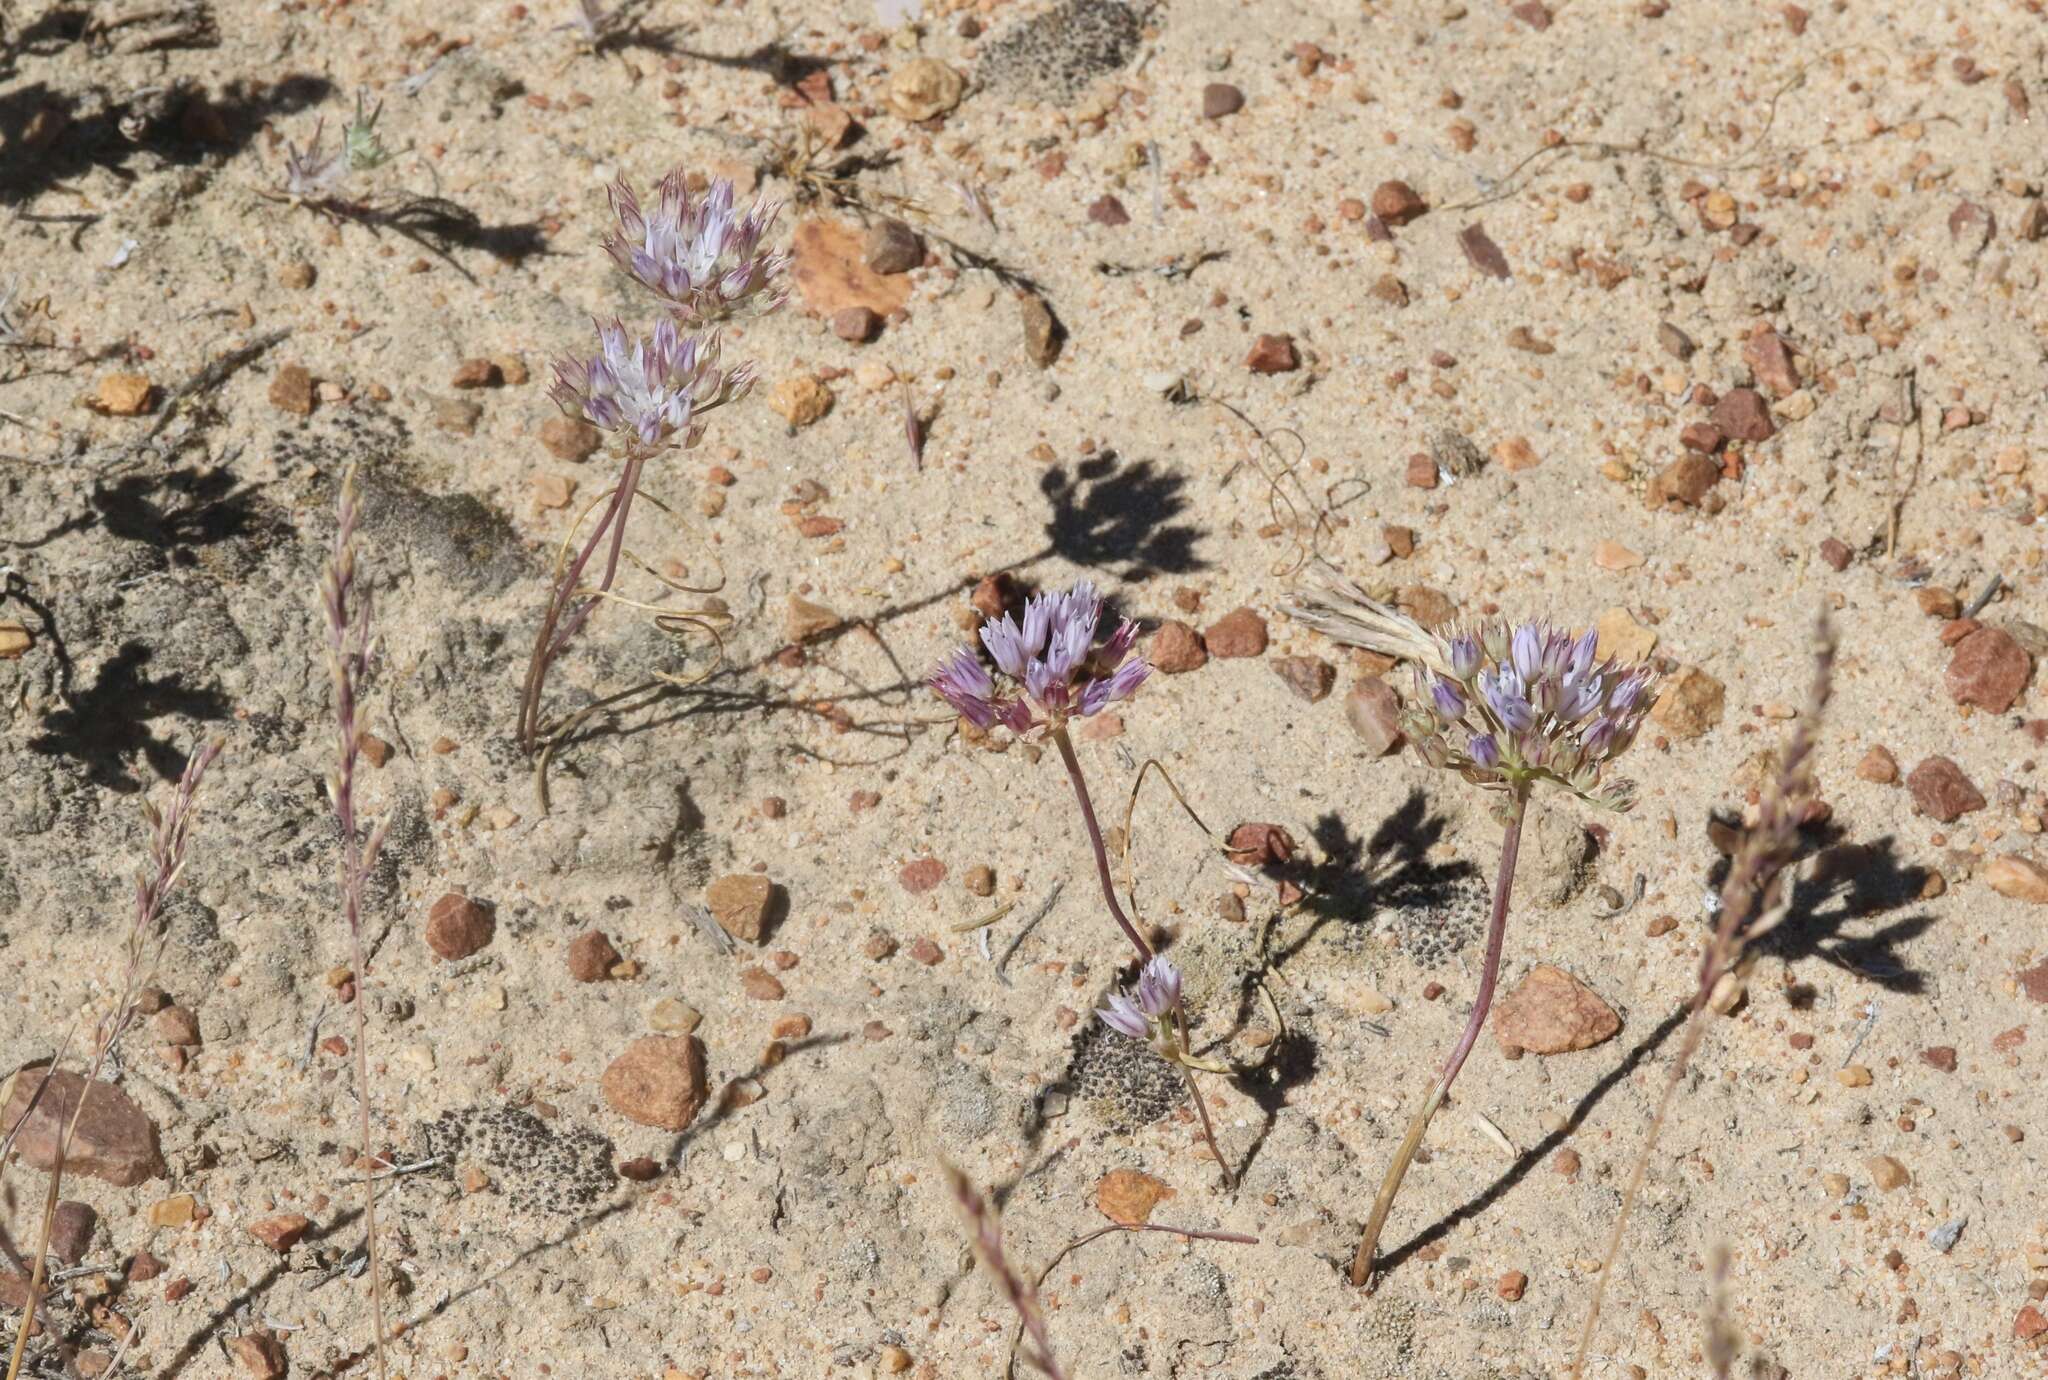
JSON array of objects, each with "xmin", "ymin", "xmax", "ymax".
[{"xmin": 930, "ymin": 579, "xmax": 1151, "ymax": 733}]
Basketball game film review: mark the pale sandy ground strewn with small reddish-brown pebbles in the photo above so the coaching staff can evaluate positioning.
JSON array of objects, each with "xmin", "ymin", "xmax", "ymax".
[{"xmin": 0, "ymin": 0, "xmax": 2048, "ymax": 1380}]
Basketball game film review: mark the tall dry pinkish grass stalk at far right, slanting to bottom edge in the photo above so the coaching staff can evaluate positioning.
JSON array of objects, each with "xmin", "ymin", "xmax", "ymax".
[{"xmin": 1571, "ymin": 614, "xmax": 1835, "ymax": 1380}]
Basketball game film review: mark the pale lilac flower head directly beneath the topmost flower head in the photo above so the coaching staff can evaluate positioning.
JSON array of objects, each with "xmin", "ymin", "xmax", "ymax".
[{"xmin": 547, "ymin": 319, "xmax": 754, "ymax": 446}]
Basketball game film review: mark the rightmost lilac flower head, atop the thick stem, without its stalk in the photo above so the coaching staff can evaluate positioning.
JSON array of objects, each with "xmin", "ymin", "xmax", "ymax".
[{"xmin": 1403, "ymin": 622, "xmax": 1657, "ymax": 809}]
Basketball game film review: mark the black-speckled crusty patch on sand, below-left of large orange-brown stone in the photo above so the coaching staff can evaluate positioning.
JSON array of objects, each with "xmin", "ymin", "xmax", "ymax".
[{"xmin": 420, "ymin": 1106, "xmax": 618, "ymax": 1216}]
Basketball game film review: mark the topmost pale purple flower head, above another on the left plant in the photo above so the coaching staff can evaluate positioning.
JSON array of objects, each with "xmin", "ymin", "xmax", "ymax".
[{"xmin": 604, "ymin": 168, "xmax": 788, "ymax": 321}]
